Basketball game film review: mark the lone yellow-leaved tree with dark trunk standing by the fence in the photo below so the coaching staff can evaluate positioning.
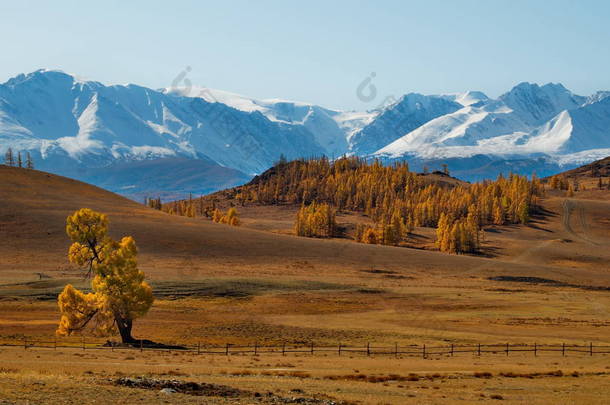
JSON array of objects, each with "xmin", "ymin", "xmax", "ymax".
[{"xmin": 57, "ymin": 208, "xmax": 154, "ymax": 343}]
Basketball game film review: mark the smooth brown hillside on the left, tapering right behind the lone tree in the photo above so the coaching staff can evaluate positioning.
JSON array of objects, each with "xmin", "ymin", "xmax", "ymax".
[{"xmin": 0, "ymin": 165, "xmax": 494, "ymax": 282}]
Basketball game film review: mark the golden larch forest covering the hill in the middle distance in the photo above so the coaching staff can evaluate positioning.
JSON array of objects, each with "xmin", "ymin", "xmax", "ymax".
[{"xmin": 154, "ymin": 157, "xmax": 544, "ymax": 253}]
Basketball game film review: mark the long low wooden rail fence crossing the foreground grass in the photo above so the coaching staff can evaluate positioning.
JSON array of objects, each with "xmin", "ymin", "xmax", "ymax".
[{"xmin": 0, "ymin": 338, "xmax": 610, "ymax": 358}]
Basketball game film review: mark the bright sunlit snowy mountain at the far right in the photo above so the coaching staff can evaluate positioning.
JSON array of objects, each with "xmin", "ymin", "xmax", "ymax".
[{"xmin": 374, "ymin": 83, "xmax": 610, "ymax": 172}]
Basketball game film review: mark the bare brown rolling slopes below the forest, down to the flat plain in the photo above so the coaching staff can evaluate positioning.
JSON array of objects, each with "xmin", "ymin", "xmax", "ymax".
[{"xmin": 0, "ymin": 161, "xmax": 610, "ymax": 286}]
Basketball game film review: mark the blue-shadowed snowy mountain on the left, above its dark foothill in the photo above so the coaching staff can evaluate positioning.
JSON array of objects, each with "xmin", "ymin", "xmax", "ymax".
[{"xmin": 0, "ymin": 71, "xmax": 338, "ymax": 174}]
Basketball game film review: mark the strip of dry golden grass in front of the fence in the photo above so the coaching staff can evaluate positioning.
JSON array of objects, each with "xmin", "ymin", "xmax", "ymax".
[{"xmin": 0, "ymin": 349, "xmax": 610, "ymax": 404}]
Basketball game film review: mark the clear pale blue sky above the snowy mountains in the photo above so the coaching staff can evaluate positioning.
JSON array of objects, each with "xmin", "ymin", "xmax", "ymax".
[{"xmin": 0, "ymin": 0, "xmax": 610, "ymax": 109}]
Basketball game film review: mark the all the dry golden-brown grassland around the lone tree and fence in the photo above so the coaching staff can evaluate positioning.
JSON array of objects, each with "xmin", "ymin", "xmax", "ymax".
[{"xmin": 0, "ymin": 166, "xmax": 610, "ymax": 404}]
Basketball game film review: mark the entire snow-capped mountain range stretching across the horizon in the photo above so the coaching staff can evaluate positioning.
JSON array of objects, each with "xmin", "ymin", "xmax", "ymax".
[{"xmin": 0, "ymin": 69, "xmax": 610, "ymax": 199}]
